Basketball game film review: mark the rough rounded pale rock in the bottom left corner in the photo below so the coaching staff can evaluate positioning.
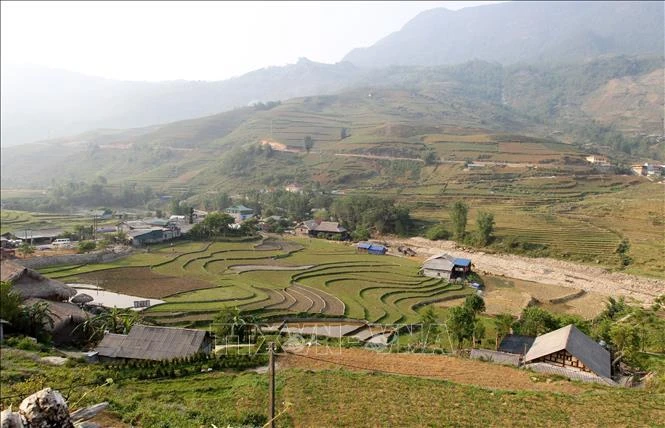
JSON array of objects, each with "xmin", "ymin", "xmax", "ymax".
[{"xmin": 19, "ymin": 388, "xmax": 74, "ymax": 428}]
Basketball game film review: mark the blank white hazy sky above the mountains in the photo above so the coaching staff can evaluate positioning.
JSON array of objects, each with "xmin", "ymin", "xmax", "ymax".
[{"xmin": 0, "ymin": 1, "xmax": 504, "ymax": 80}]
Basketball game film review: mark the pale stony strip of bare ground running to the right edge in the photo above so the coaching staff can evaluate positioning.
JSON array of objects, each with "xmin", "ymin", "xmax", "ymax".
[{"xmin": 382, "ymin": 237, "xmax": 665, "ymax": 304}]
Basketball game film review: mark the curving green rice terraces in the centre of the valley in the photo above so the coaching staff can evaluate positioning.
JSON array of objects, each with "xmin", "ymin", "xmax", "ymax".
[{"xmin": 42, "ymin": 238, "xmax": 471, "ymax": 326}]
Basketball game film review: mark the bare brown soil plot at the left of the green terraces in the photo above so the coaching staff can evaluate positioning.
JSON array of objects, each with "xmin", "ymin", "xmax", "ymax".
[{"xmin": 76, "ymin": 267, "xmax": 212, "ymax": 299}]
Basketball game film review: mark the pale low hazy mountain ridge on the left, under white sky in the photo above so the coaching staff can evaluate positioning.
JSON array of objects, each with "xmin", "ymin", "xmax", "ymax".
[{"xmin": 1, "ymin": 58, "xmax": 359, "ymax": 147}]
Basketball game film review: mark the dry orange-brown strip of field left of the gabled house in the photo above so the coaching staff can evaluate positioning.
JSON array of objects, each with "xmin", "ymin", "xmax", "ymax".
[{"xmin": 277, "ymin": 346, "xmax": 582, "ymax": 394}]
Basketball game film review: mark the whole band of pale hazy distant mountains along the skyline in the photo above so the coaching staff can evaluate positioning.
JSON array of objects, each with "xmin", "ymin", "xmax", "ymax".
[{"xmin": 2, "ymin": 2, "xmax": 663, "ymax": 147}]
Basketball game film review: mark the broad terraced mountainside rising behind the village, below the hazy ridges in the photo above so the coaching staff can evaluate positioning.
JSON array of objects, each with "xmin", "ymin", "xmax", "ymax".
[{"xmin": 1, "ymin": 56, "xmax": 664, "ymax": 195}]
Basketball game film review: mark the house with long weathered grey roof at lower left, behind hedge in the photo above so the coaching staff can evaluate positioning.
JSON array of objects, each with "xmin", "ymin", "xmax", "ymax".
[{"xmin": 95, "ymin": 325, "xmax": 213, "ymax": 361}]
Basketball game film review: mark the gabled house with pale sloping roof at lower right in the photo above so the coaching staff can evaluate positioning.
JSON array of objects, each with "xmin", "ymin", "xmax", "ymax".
[{"xmin": 524, "ymin": 324, "xmax": 612, "ymax": 379}]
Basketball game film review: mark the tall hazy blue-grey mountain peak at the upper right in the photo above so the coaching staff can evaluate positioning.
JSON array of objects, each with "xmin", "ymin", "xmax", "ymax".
[{"xmin": 344, "ymin": 1, "xmax": 665, "ymax": 67}]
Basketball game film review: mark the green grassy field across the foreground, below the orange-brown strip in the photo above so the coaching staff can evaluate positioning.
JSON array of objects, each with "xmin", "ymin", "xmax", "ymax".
[{"xmin": 0, "ymin": 348, "xmax": 665, "ymax": 427}]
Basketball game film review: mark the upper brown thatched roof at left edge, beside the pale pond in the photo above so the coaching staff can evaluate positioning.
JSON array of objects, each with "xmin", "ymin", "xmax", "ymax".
[{"xmin": 0, "ymin": 260, "xmax": 76, "ymax": 301}]
